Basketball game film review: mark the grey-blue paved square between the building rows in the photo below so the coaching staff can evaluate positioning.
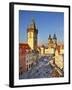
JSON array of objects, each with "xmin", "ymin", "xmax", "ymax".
[{"xmin": 19, "ymin": 56, "xmax": 53, "ymax": 79}]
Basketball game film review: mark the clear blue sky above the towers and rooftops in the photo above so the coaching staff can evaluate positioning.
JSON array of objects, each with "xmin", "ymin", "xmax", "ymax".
[{"xmin": 19, "ymin": 10, "xmax": 64, "ymax": 45}]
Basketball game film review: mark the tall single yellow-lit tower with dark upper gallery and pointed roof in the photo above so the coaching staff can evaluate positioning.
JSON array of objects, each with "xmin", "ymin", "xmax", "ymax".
[{"xmin": 27, "ymin": 19, "xmax": 38, "ymax": 50}]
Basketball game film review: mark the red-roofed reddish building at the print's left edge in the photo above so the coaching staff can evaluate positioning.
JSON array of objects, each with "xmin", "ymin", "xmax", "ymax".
[{"xmin": 19, "ymin": 43, "xmax": 31, "ymax": 74}]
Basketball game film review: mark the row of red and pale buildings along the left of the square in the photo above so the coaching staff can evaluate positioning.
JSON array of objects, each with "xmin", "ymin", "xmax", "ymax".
[{"xmin": 19, "ymin": 43, "xmax": 39, "ymax": 74}]
